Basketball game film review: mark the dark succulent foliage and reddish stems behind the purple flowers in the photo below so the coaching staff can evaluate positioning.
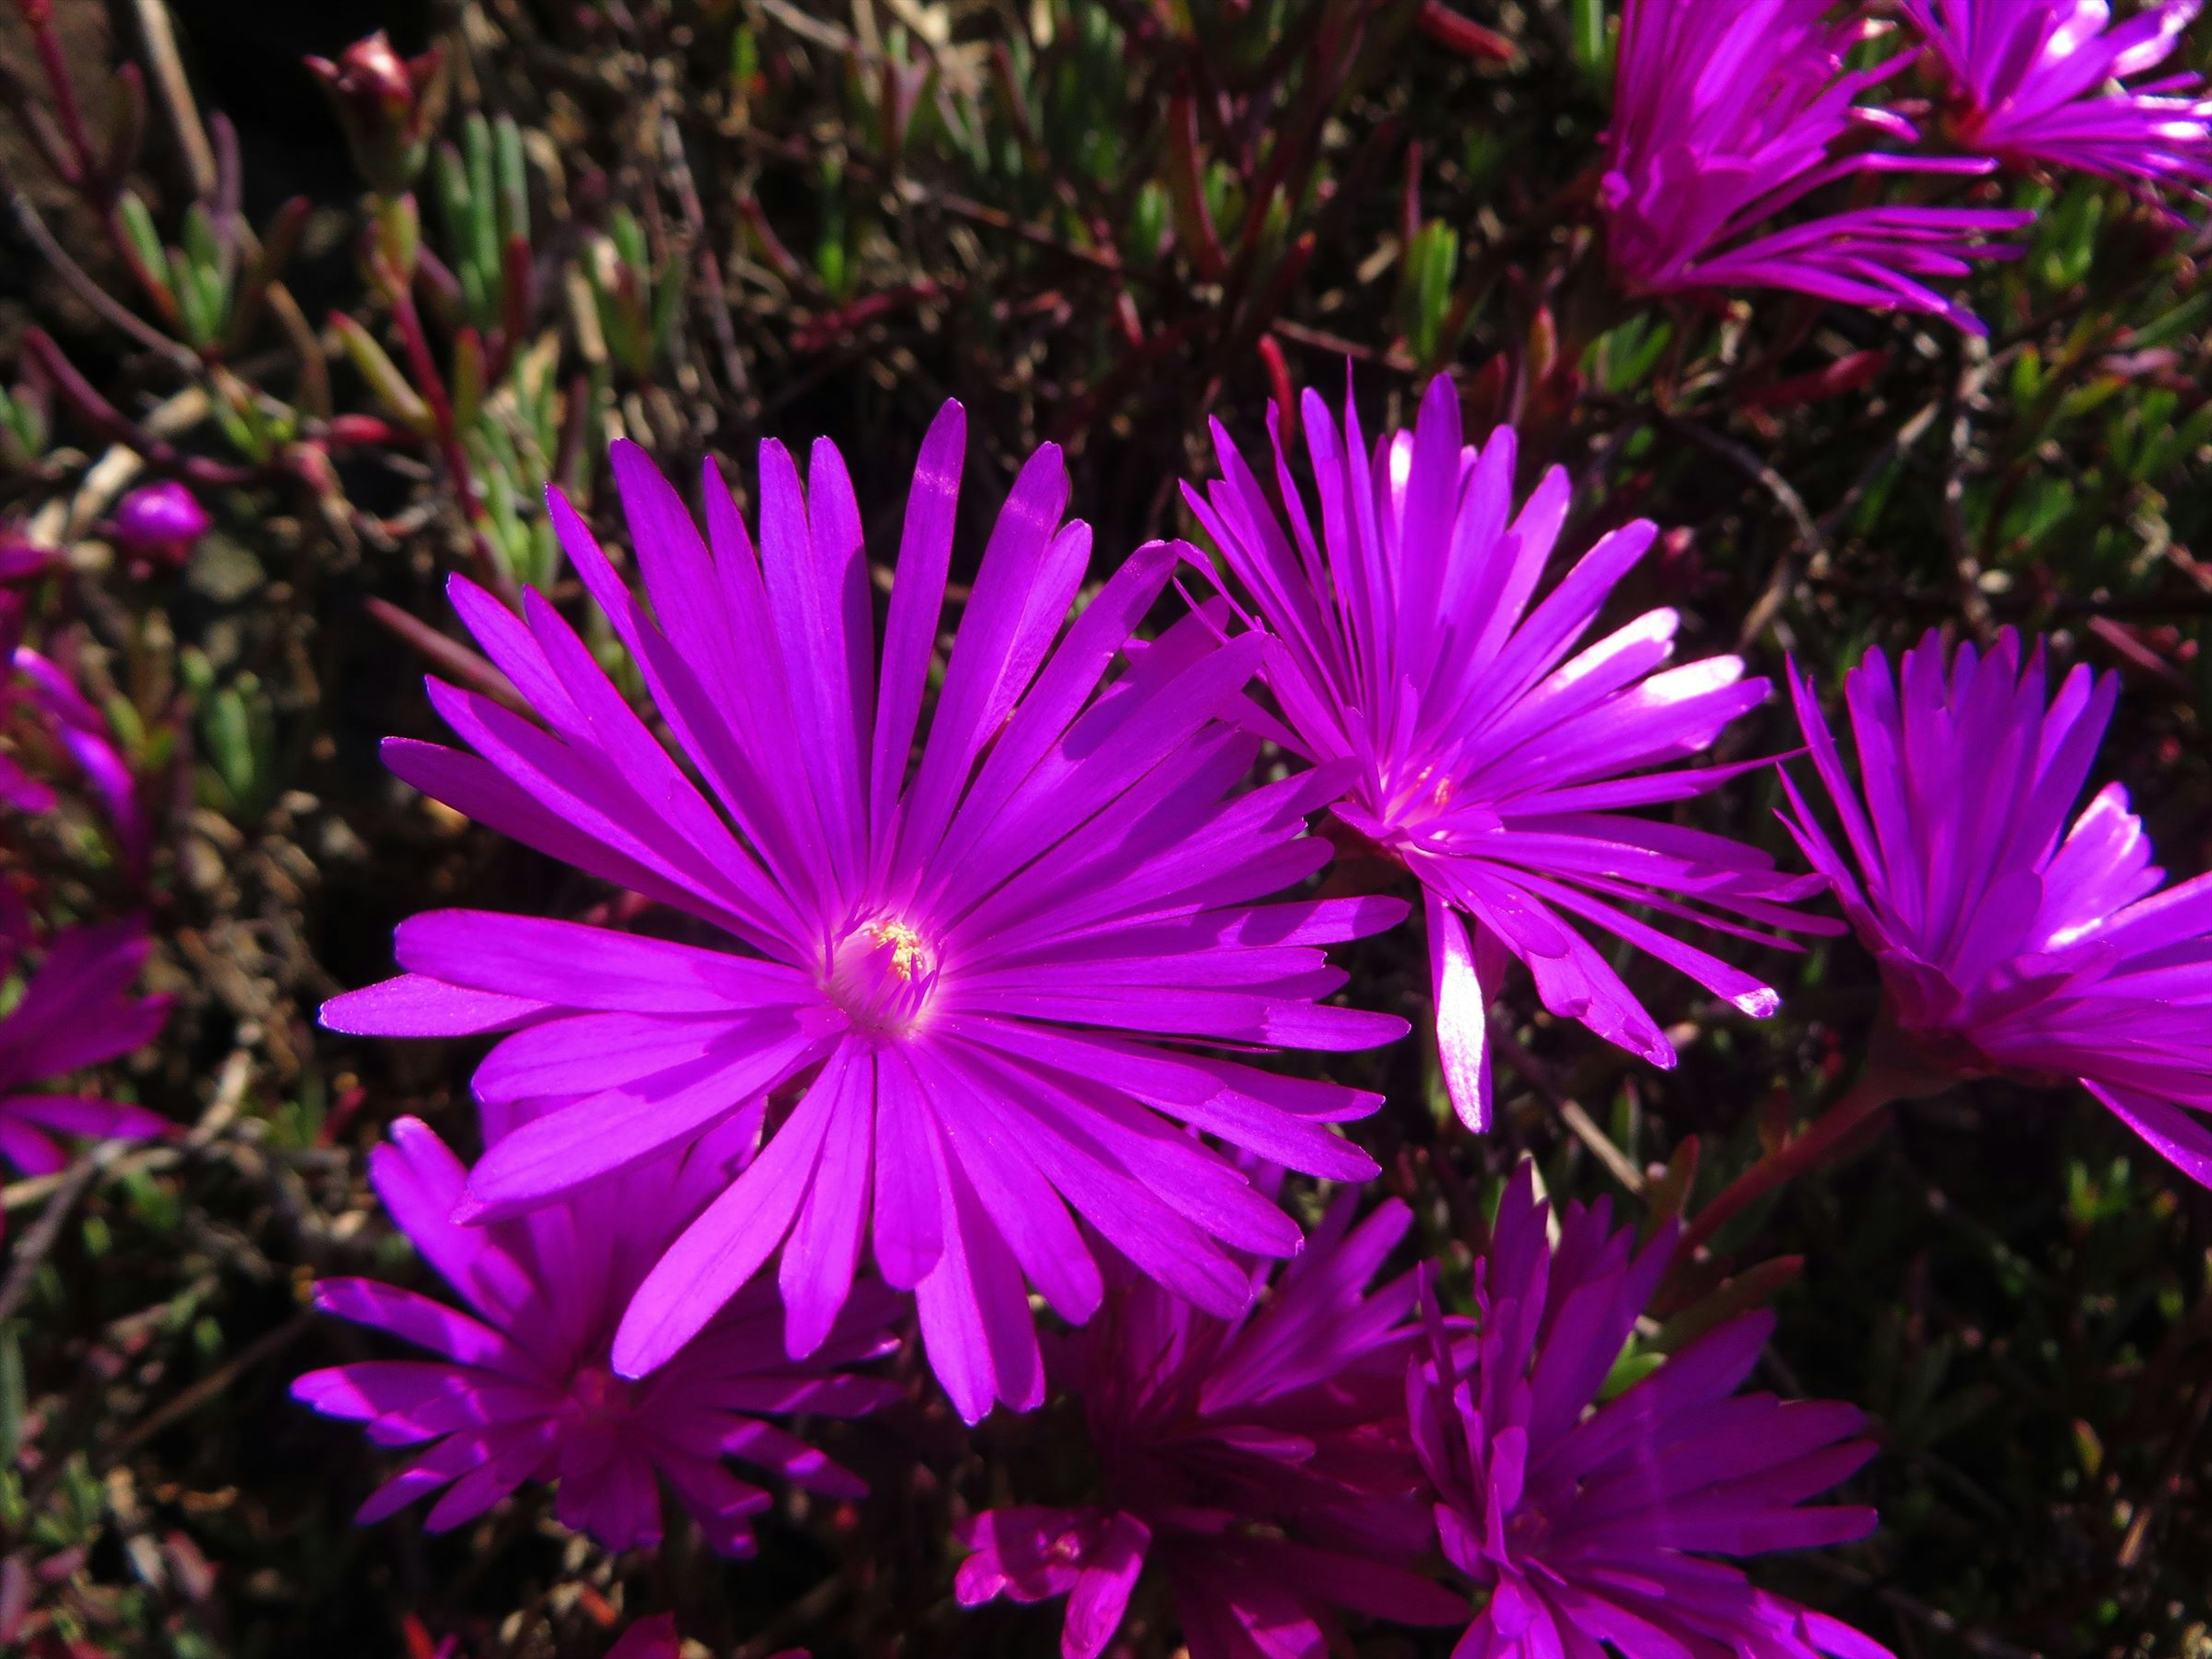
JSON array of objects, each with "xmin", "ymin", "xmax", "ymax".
[{"xmin": 0, "ymin": 0, "xmax": 2212, "ymax": 1659}]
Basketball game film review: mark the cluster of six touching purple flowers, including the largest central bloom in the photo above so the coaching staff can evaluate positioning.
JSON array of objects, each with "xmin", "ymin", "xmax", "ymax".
[{"xmin": 298, "ymin": 351, "xmax": 2212, "ymax": 1659}]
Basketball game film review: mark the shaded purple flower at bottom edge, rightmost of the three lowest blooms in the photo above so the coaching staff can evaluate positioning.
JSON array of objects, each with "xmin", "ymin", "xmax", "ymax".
[{"xmin": 1407, "ymin": 1159, "xmax": 1887, "ymax": 1659}]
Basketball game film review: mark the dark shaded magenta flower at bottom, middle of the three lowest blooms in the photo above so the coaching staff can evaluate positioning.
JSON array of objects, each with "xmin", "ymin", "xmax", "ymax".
[{"xmin": 956, "ymin": 1192, "xmax": 1467, "ymax": 1659}]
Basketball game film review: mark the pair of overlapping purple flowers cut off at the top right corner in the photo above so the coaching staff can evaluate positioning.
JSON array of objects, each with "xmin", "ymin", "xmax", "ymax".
[{"xmin": 1597, "ymin": 0, "xmax": 2212, "ymax": 334}]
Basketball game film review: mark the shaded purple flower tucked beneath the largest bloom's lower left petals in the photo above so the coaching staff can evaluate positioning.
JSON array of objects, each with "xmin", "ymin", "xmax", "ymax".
[{"xmin": 292, "ymin": 1113, "xmax": 898, "ymax": 1555}]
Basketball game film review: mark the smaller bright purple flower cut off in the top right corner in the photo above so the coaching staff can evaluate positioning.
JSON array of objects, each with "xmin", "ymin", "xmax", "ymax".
[{"xmin": 1904, "ymin": 0, "xmax": 2212, "ymax": 181}]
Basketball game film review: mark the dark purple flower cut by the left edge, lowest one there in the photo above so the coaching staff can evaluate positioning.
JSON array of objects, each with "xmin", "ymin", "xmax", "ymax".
[{"xmin": 0, "ymin": 920, "xmax": 171, "ymax": 1175}]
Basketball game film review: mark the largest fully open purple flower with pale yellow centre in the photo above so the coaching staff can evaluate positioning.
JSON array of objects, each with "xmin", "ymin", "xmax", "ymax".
[{"xmin": 323, "ymin": 405, "xmax": 1404, "ymax": 1420}]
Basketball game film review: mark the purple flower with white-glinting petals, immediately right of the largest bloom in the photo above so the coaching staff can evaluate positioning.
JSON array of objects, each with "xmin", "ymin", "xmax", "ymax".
[{"xmin": 1183, "ymin": 376, "xmax": 1818, "ymax": 1128}]
